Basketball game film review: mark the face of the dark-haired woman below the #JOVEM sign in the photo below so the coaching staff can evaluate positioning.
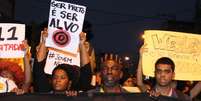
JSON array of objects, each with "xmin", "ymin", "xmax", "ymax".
[{"xmin": 52, "ymin": 69, "xmax": 69, "ymax": 91}]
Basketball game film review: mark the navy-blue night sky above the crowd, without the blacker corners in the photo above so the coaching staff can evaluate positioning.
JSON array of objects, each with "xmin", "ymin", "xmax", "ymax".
[{"xmin": 15, "ymin": 0, "xmax": 196, "ymax": 54}]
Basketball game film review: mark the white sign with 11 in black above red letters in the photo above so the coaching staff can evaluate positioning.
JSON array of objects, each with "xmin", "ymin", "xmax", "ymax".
[{"xmin": 0, "ymin": 23, "xmax": 25, "ymax": 58}]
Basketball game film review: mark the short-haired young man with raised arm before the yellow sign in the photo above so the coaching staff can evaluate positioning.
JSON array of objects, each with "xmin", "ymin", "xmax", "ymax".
[{"xmin": 137, "ymin": 46, "xmax": 191, "ymax": 101}]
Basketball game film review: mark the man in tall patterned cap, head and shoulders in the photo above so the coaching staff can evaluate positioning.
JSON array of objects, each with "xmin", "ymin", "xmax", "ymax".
[{"xmin": 89, "ymin": 54, "xmax": 127, "ymax": 93}]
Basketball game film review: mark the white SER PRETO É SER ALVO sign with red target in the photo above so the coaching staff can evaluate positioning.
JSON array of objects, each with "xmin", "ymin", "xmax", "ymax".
[{"xmin": 46, "ymin": 0, "xmax": 86, "ymax": 54}]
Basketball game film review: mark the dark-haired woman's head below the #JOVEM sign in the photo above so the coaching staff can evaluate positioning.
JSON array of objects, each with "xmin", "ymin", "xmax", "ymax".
[{"xmin": 47, "ymin": 64, "xmax": 79, "ymax": 95}]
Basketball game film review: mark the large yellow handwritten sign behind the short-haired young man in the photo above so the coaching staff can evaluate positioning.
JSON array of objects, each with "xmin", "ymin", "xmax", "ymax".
[{"xmin": 142, "ymin": 30, "xmax": 201, "ymax": 80}]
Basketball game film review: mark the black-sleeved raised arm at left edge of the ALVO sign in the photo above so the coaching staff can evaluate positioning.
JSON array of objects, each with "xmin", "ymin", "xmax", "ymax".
[{"xmin": 33, "ymin": 28, "xmax": 51, "ymax": 92}]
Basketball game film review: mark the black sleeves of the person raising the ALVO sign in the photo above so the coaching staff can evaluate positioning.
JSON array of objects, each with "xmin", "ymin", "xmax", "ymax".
[{"xmin": 33, "ymin": 59, "xmax": 92, "ymax": 92}]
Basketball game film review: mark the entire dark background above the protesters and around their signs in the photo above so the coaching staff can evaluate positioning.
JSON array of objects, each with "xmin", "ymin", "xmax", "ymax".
[{"xmin": 0, "ymin": 0, "xmax": 201, "ymax": 72}]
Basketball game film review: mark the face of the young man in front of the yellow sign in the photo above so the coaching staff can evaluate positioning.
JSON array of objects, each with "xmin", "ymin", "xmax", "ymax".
[{"xmin": 155, "ymin": 64, "xmax": 175, "ymax": 87}]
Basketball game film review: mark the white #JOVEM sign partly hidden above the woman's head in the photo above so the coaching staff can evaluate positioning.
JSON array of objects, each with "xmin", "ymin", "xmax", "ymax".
[{"xmin": 44, "ymin": 49, "xmax": 80, "ymax": 74}]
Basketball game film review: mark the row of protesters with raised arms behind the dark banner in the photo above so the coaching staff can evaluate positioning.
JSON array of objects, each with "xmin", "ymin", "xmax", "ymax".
[{"xmin": 0, "ymin": 21, "xmax": 201, "ymax": 101}]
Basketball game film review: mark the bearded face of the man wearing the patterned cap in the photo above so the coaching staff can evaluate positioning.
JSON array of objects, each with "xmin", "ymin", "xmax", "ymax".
[{"xmin": 101, "ymin": 60, "xmax": 122, "ymax": 86}]
